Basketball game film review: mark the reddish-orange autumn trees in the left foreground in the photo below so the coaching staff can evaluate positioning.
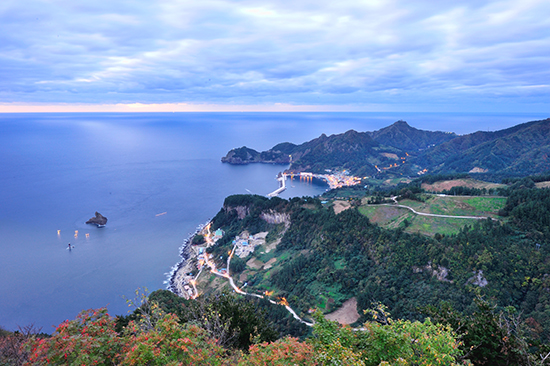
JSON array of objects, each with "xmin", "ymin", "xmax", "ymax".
[{"xmin": 27, "ymin": 306, "xmax": 226, "ymax": 366}]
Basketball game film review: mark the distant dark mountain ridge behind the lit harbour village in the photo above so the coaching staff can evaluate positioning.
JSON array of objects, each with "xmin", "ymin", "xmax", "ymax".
[{"xmin": 222, "ymin": 119, "xmax": 550, "ymax": 176}]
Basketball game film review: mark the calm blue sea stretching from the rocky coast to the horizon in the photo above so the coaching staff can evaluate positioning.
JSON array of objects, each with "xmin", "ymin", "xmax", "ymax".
[{"xmin": 0, "ymin": 113, "xmax": 548, "ymax": 333}]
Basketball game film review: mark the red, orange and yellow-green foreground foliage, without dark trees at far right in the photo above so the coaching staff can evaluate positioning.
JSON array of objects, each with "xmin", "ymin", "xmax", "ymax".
[{"xmin": 0, "ymin": 295, "xmax": 470, "ymax": 366}]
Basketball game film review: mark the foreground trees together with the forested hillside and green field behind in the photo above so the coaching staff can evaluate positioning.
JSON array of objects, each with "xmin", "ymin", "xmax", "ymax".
[{"xmin": 4, "ymin": 173, "xmax": 550, "ymax": 366}]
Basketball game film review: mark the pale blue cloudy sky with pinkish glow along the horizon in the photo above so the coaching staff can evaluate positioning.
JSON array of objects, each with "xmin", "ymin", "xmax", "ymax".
[{"xmin": 0, "ymin": 0, "xmax": 550, "ymax": 112}]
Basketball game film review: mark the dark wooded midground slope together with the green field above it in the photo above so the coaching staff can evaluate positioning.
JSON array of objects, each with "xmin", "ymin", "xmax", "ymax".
[{"xmin": 202, "ymin": 176, "xmax": 550, "ymax": 354}]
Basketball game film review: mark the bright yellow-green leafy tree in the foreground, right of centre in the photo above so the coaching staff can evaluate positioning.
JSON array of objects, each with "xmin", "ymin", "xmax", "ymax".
[{"xmin": 312, "ymin": 307, "xmax": 462, "ymax": 366}]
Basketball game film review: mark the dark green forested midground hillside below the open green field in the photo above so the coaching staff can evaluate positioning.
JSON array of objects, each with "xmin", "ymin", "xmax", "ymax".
[{"xmin": 206, "ymin": 179, "xmax": 550, "ymax": 342}]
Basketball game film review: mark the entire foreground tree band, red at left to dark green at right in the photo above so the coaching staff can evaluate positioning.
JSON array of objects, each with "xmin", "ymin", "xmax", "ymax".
[{"xmin": 7, "ymin": 290, "xmax": 548, "ymax": 366}]
